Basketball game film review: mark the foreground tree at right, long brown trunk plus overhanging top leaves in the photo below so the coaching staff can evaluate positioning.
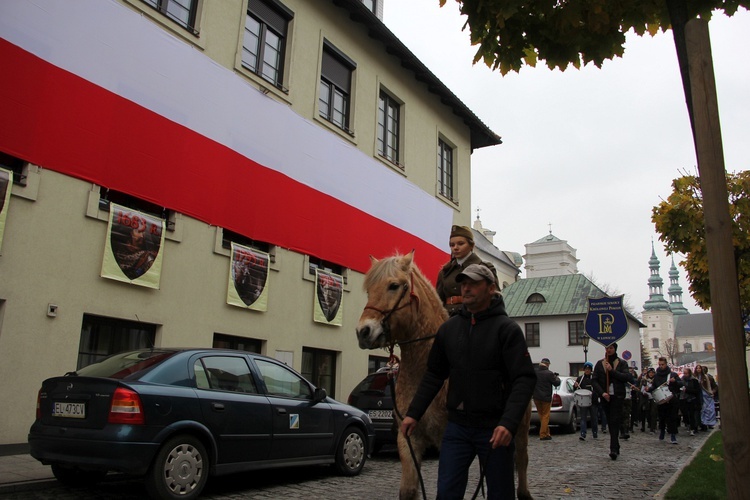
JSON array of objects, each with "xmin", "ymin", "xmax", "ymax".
[{"xmin": 438, "ymin": 0, "xmax": 750, "ymax": 498}]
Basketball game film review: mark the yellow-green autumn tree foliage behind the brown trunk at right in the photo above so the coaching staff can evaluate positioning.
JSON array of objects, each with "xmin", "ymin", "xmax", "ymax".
[{"xmin": 651, "ymin": 170, "xmax": 750, "ymax": 323}]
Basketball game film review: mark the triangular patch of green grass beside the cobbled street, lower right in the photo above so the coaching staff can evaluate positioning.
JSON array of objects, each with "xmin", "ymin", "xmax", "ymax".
[{"xmin": 664, "ymin": 431, "xmax": 727, "ymax": 500}]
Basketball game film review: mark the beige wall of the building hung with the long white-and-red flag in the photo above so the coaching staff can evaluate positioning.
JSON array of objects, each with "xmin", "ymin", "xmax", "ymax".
[{"xmin": 0, "ymin": 0, "xmax": 488, "ymax": 444}]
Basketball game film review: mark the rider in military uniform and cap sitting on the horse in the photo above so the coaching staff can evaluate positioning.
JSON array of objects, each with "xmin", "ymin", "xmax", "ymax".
[{"xmin": 435, "ymin": 226, "xmax": 498, "ymax": 316}]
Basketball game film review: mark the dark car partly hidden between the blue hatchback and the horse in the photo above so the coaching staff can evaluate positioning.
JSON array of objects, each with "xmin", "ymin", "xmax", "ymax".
[{"xmin": 347, "ymin": 367, "xmax": 398, "ymax": 453}]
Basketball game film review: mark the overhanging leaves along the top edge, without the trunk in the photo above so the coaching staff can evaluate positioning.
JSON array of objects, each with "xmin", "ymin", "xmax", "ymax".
[{"xmin": 446, "ymin": 0, "xmax": 750, "ymax": 75}]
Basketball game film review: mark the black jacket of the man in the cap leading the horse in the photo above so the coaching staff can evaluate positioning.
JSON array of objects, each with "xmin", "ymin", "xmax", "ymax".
[{"xmin": 406, "ymin": 295, "xmax": 536, "ymax": 434}]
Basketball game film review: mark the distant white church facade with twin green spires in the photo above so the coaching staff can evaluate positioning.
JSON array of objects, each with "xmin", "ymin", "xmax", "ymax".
[{"xmin": 641, "ymin": 242, "xmax": 682, "ymax": 366}]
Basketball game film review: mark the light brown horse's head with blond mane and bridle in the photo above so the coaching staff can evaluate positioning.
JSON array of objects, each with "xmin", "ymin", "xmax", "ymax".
[{"xmin": 357, "ymin": 251, "xmax": 445, "ymax": 349}]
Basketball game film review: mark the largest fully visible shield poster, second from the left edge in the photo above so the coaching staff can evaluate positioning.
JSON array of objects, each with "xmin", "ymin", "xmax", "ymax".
[{"xmin": 102, "ymin": 203, "xmax": 164, "ymax": 289}]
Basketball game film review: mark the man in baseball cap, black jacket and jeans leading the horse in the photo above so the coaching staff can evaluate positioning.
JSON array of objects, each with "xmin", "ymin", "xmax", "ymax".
[{"xmin": 401, "ymin": 264, "xmax": 536, "ymax": 499}]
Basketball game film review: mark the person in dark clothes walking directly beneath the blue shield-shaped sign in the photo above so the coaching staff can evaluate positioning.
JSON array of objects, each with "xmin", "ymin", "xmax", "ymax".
[{"xmin": 593, "ymin": 343, "xmax": 633, "ymax": 460}]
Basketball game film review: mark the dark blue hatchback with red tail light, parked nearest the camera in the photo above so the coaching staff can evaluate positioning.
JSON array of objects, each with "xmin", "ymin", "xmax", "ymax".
[{"xmin": 29, "ymin": 349, "xmax": 375, "ymax": 499}]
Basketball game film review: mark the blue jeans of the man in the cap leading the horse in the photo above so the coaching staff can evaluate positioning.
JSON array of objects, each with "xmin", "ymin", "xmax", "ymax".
[{"xmin": 437, "ymin": 422, "xmax": 516, "ymax": 500}]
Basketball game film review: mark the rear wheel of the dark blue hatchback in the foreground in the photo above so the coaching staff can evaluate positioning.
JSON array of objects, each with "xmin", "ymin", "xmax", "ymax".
[{"xmin": 146, "ymin": 435, "xmax": 209, "ymax": 500}]
